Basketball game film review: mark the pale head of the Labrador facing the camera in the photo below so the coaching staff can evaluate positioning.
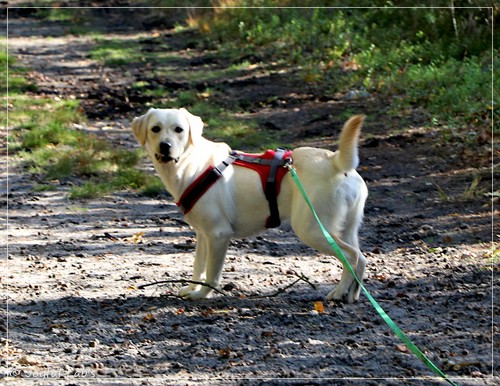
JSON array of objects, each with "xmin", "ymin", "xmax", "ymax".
[{"xmin": 132, "ymin": 109, "xmax": 203, "ymax": 163}]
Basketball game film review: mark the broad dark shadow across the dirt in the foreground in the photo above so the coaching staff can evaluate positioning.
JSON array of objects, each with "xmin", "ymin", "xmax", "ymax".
[{"xmin": 5, "ymin": 267, "xmax": 498, "ymax": 385}]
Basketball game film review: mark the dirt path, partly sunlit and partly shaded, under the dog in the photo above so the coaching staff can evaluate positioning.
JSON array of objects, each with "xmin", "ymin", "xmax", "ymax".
[{"xmin": 0, "ymin": 6, "xmax": 498, "ymax": 385}]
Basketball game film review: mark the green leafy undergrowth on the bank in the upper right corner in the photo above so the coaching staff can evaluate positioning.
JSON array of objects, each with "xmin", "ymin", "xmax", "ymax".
[{"xmin": 197, "ymin": 0, "xmax": 500, "ymax": 128}]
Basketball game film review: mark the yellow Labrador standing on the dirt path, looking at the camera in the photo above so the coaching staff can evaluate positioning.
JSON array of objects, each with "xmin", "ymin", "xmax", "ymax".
[{"xmin": 132, "ymin": 109, "xmax": 368, "ymax": 303}]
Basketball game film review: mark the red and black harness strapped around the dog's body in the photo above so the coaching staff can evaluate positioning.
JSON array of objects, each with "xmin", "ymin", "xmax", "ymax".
[{"xmin": 177, "ymin": 149, "xmax": 292, "ymax": 228}]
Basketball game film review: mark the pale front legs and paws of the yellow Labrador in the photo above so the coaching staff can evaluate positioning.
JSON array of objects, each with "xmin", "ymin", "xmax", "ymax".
[{"xmin": 180, "ymin": 232, "xmax": 231, "ymax": 300}]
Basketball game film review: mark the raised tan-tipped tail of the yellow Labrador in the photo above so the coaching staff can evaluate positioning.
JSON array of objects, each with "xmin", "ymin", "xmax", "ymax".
[{"xmin": 333, "ymin": 115, "xmax": 365, "ymax": 173}]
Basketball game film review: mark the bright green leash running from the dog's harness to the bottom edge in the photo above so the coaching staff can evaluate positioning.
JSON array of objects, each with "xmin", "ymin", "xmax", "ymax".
[{"xmin": 288, "ymin": 165, "xmax": 458, "ymax": 386}]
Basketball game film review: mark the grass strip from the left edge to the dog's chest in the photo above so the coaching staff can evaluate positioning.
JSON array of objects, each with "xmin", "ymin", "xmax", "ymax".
[{"xmin": 0, "ymin": 45, "xmax": 162, "ymax": 199}]
